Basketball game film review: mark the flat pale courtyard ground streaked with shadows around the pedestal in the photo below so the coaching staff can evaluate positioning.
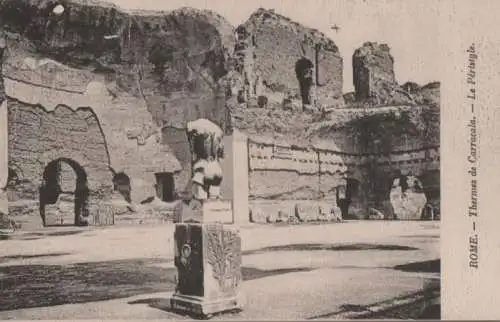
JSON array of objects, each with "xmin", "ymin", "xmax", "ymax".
[{"xmin": 0, "ymin": 221, "xmax": 440, "ymax": 320}]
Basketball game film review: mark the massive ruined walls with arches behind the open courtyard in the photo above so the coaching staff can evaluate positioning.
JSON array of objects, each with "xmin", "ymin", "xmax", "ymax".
[{"xmin": 0, "ymin": 0, "xmax": 440, "ymax": 228}]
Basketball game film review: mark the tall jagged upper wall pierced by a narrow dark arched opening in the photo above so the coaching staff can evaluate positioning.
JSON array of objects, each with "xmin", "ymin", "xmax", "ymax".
[{"xmin": 237, "ymin": 8, "xmax": 343, "ymax": 109}]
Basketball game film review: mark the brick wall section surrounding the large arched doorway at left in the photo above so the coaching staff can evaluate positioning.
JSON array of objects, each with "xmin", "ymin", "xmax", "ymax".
[{"xmin": 8, "ymin": 99, "xmax": 112, "ymax": 199}]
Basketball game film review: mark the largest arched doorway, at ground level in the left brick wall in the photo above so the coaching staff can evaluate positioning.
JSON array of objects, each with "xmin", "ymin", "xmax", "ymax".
[{"xmin": 39, "ymin": 158, "xmax": 89, "ymax": 226}]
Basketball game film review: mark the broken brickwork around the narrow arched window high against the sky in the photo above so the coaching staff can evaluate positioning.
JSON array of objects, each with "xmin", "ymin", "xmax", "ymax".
[{"xmin": 243, "ymin": 9, "xmax": 343, "ymax": 102}]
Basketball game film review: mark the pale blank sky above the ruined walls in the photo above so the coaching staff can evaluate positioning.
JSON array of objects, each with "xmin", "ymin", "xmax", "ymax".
[{"xmin": 107, "ymin": 0, "xmax": 442, "ymax": 92}]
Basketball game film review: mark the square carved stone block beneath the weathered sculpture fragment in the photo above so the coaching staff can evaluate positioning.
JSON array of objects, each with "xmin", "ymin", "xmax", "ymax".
[{"xmin": 170, "ymin": 223, "xmax": 243, "ymax": 317}]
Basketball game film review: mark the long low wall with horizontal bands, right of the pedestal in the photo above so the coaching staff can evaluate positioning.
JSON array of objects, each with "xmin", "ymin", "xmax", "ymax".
[{"xmin": 248, "ymin": 140, "xmax": 439, "ymax": 220}]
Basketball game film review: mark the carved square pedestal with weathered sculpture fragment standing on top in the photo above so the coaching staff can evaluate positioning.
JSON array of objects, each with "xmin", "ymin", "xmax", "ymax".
[{"xmin": 171, "ymin": 119, "xmax": 244, "ymax": 317}]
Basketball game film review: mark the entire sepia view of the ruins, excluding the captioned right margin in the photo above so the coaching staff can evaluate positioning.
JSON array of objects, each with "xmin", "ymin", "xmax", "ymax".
[{"xmin": 0, "ymin": 0, "xmax": 440, "ymax": 320}]
